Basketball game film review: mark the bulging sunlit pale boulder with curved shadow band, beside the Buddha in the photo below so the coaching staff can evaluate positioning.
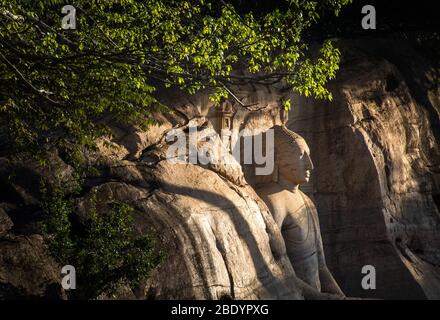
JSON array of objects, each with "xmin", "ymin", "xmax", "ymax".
[{"xmin": 80, "ymin": 125, "xmax": 335, "ymax": 299}]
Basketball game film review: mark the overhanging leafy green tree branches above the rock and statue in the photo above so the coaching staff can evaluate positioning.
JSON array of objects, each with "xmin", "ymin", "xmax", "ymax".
[{"xmin": 0, "ymin": 0, "xmax": 351, "ymax": 155}]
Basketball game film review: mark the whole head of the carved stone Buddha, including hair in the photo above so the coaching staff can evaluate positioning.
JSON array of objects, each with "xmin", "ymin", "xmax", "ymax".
[{"xmin": 273, "ymin": 126, "xmax": 313, "ymax": 185}]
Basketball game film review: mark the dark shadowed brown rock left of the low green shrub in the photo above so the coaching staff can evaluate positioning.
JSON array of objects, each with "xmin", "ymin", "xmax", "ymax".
[{"xmin": 0, "ymin": 154, "xmax": 72, "ymax": 299}]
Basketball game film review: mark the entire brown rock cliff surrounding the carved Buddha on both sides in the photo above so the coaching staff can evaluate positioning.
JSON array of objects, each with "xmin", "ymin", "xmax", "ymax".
[{"xmin": 0, "ymin": 39, "xmax": 440, "ymax": 299}]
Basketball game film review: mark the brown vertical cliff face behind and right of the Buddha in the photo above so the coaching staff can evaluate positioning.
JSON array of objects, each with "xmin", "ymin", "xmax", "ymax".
[{"xmin": 288, "ymin": 39, "xmax": 440, "ymax": 299}]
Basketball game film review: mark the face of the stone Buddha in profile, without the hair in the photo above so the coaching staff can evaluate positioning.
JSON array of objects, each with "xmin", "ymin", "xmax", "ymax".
[{"xmin": 277, "ymin": 139, "xmax": 313, "ymax": 185}]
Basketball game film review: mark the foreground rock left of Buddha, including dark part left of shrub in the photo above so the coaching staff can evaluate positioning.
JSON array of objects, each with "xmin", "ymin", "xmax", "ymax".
[{"xmin": 0, "ymin": 113, "xmax": 337, "ymax": 299}]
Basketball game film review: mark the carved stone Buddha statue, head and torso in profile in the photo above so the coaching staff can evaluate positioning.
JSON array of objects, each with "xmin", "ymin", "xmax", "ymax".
[{"xmin": 256, "ymin": 126, "xmax": 344, "ymax": 295}]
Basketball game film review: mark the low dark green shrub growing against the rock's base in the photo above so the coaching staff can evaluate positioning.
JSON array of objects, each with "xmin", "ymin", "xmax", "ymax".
[{"xmin": 41, "ymin": 191, "xmax": 164, "ymax": 299}]
